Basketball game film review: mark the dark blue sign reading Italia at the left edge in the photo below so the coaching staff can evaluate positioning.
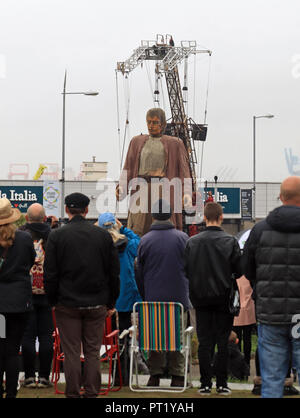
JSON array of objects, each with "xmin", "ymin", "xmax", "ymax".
[{"xmin": 0, "ymin": 186, "xmax": 43, "ymax": 213}]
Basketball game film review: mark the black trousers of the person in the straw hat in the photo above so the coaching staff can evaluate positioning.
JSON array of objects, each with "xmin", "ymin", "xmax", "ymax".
[{"xmin": 0, "ymin": 312, "xmax": 28, "ymax": 398}]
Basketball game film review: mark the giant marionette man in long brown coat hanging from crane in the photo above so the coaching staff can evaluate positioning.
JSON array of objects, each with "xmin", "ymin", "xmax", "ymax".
[{"xmin": 116, "ymin": 108, "xmax": 192, "ymax": 236}]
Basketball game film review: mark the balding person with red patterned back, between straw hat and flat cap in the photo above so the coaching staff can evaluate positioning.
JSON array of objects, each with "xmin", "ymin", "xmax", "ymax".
[{"xmin": 20, "ymin": 203, "xmax": 53, "ymax": 388}]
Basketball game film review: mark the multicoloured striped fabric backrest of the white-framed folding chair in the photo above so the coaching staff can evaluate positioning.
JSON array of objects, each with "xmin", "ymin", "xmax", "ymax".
[{"xmin": 136, "ymin": 302, "xmax": 182, "ymax": 351}]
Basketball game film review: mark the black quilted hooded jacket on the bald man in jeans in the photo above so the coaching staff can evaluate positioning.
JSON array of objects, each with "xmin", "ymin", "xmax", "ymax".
[{"xmin": 244, "ymin": 205, "xmax": 300, "ymax": 325}]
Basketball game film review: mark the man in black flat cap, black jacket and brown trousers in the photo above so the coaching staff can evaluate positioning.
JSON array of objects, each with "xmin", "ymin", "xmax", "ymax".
[{"xmin": 44, "ymin": 193, "xmax": 120, "ymax": 398}]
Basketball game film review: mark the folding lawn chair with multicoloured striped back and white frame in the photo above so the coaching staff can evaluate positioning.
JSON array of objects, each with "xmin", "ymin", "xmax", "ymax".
[{"xmin": 129, "ymin": 302, "xmax": 193, "ymax": 392}]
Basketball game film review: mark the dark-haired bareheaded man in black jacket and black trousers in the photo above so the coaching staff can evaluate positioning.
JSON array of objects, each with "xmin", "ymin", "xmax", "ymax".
[{"xmin": 185, "ymin": 202, "xmax": 242, "ymax": 395}]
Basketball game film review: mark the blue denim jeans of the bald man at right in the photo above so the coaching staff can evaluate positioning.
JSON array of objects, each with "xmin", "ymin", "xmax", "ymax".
[{"xmin": 258, "ymin": 324, "xmax": 300, "ymax": 398}]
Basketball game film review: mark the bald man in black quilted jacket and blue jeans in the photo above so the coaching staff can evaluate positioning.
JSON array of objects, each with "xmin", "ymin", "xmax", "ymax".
[{"xmin": 243, "ymin": 176, "xmax": 300, "ymax": 398}]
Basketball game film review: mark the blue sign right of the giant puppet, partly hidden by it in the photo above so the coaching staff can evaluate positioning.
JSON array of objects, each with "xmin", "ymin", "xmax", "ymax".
[{"xmin": 204, "ymin": 187, "xmax": 241, "ymax": 215}]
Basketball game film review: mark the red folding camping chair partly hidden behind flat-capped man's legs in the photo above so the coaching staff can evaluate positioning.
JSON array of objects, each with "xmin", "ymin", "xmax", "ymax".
[{"xmin": 51, "ymin": 309, "xmax": 122, "ymax": 395}]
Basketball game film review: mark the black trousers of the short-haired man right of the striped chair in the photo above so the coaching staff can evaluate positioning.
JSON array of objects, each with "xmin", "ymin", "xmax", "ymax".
[{"xmin": 196, "ymin": 307, "xmax": 233, "ymax": 387}]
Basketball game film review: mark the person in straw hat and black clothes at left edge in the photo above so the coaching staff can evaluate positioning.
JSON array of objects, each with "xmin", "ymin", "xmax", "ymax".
[{"xmin": 0, "ymin": 198, "xmax": 35, "ymax": 398}]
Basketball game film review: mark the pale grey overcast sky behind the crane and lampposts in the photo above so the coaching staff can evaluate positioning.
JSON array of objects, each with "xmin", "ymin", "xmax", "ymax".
[{"xmin": 0, "ymin": 0, "xmax": 300, "ymax": 182}]
